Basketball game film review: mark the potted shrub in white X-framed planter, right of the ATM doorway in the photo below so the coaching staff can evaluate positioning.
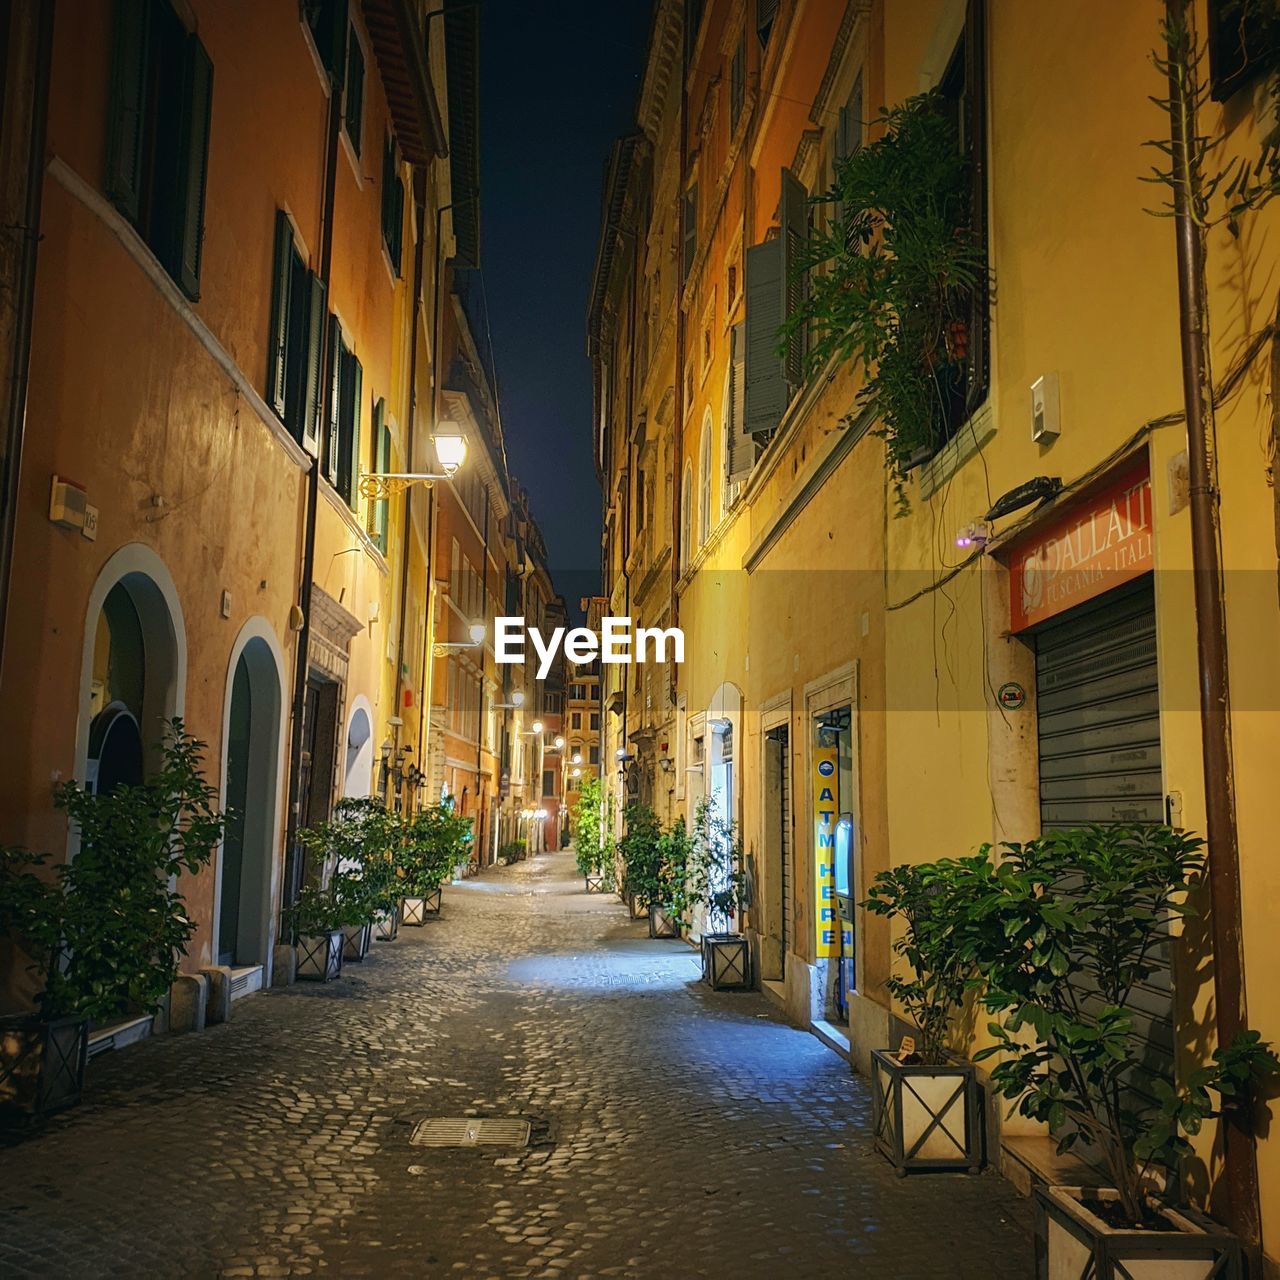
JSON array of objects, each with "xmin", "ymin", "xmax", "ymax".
[{"xmin": 861, "ymin": 858, "xmax": 984, "ymax": 1176}]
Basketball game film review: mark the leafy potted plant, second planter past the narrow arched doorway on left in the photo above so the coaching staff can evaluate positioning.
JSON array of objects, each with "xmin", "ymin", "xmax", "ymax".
[{"xmin": 298, "ymin": 796, "xmax": 401, "ymax": 960}]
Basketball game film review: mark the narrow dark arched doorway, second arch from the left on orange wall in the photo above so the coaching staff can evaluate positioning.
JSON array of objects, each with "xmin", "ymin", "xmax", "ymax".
[{"xmin": 216, "ymin": 635, "xmax": 283, "ymax": 966}]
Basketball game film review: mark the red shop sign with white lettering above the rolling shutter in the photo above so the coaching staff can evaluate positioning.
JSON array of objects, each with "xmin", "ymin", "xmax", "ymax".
[{"xmin": 1009, "ymin": 460, "xmax": 1155, "ymax": 631}]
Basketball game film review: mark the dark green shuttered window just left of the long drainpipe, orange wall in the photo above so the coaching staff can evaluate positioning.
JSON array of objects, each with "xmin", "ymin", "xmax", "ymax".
[{"xmin": 266, "ymin": 216, "xmax": 325, "ymax": 454}]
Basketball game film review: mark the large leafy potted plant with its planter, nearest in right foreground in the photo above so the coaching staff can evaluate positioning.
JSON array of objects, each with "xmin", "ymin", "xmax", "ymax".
[{"xmin": 965, "ymin": 826, "xmax": 1280, "ymax": 1280}]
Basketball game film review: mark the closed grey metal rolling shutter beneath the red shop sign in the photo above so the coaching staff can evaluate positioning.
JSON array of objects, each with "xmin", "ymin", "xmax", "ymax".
[{"xmin": 1034, "ymin": 576, "xmax": 1174, "ymax": 1111}]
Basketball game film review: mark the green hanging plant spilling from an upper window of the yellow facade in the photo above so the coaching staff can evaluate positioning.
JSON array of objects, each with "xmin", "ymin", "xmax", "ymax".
[{"xmin": 783, "ymin": 93, "xmax": 987, "ymax": 509}]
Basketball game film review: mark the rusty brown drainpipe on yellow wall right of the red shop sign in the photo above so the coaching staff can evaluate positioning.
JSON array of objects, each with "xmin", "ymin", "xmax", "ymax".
[{"xmin": 1165, "ymin": 0, "xmax": 1262, "ymax": 1252}]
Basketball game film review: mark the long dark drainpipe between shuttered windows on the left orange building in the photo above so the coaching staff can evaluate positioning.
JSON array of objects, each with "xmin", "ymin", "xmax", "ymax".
[{"xmin": 280, "ymin": 64, "xmax": 342, "ymax": 929}]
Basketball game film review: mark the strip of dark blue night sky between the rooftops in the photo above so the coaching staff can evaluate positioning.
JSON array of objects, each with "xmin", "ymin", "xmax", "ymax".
[{"xmin": 480, "ymin": 0, "xmax": 652, "ymax": 612}]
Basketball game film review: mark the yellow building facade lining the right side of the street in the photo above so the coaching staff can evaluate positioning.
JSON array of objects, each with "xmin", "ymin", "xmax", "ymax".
[{"xmin": 590, "ymin": 0, "xmax": 1280, "ymax": 1257}]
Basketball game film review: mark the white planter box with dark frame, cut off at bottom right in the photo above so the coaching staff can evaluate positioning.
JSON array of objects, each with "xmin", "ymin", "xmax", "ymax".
[{"xmin": 1036, "ymin": 1187, "xmax": 1244, "ymax": 1280}]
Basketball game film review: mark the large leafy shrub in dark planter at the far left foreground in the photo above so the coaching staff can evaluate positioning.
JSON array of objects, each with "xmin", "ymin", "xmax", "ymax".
[{"xmin": 0, "ymin": 719, "xmax": 225, "ymax": 1119}]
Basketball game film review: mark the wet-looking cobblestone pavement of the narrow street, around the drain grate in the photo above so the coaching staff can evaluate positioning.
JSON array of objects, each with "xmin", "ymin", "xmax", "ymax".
[{"xmin": 0, "ymin": 855, "xmax": 1032, "ymax": 1280}]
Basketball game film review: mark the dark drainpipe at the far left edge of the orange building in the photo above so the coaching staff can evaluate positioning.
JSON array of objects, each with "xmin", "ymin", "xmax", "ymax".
[{"xmin": 0, "ymin": 0, "xmax": 54, "ymax": 691}]
